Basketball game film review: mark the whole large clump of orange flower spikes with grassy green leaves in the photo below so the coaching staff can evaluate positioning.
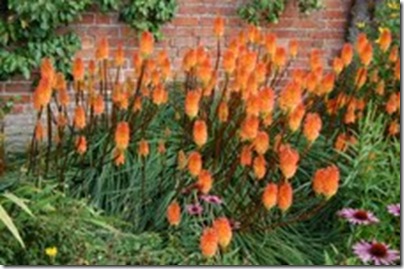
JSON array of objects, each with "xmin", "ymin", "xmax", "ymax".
[{"xmin": 31, "ymin": 18, "xmax": 400, "ymax": 257}]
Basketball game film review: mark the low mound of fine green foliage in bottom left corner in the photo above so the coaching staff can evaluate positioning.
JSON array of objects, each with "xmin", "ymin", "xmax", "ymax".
[{"xmin": 0, "ymin": 178, "xmax": 186, "ymax": 265}]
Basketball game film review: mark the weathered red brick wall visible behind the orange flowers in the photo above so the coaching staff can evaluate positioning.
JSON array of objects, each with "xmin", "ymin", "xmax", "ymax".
[{"xmin": 0, "ymin": 0, "xmax": 351, "ymax": 149}]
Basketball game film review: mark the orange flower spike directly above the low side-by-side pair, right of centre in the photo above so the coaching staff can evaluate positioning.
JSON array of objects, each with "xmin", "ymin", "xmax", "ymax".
[{"xmin": 278, "ymin": 145, "xmax": 300, "ymax": 179}]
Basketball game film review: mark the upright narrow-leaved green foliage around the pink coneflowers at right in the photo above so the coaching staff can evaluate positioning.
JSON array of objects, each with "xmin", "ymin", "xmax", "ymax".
[{"xmin": 326, "ymin": 105, "xmax": 401, "ymax": 265}]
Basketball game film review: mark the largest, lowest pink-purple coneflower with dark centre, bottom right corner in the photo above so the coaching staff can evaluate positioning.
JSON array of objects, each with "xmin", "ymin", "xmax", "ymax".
[{"xmin": 353, "ymin": 241, "xmax": 400, "ymax": 265}]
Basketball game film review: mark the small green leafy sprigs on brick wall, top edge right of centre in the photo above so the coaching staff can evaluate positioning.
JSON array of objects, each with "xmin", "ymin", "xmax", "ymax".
[{"xmin": 238, "ymin": 0, "xmax": 323, "ymax": 25}]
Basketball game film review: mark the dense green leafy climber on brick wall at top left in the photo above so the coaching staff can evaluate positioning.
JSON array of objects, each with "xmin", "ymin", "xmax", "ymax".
[{"xmin": 0, "ymin": 0, "xmax": 176, "ymax": 80}]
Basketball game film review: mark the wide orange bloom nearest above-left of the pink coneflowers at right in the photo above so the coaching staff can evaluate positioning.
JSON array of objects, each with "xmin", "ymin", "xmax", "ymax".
[{"xmin": 313, "ymin": 165, "xmax": 340, "ymax": 200}]
